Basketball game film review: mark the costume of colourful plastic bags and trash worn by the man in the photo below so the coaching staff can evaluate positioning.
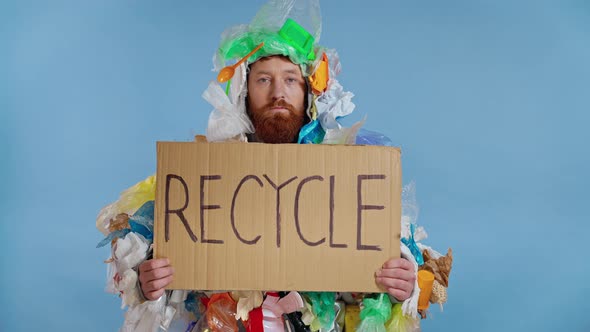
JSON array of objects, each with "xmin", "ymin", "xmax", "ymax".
[{"xmin": 96, "ymin": 0, "xmax": 452, "ymax": 332}]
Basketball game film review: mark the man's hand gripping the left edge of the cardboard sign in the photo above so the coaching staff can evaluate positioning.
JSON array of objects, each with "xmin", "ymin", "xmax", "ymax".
[{"xmin": 139, "ymin": 258, "xmax": 174, "ymax": 301}]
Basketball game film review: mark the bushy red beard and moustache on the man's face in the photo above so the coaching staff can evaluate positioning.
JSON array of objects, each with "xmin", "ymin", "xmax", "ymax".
[{"xmin": 250, "ymin": 99, "xmax": 304, "ymax": 143}]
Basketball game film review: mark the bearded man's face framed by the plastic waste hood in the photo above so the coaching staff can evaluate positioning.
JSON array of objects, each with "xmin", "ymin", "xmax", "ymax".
[{"xmin": 248, "ymin": 56, "xmax": 307, "ymax": 143}]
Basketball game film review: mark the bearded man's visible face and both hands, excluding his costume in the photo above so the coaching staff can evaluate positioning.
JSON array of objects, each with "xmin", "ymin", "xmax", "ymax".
[{"xmin": 139, "ymin": 55, "xmax": 415, "ymax": 301}]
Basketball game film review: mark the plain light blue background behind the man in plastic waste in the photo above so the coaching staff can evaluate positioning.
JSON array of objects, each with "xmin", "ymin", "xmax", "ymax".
[{"xmin": 0, "ymin": 0, "xmax": 590, "ymax": 331}]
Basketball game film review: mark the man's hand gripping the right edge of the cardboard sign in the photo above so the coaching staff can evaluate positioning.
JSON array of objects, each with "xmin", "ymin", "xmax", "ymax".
[{"xmin": 375, "ymin": 258, "xmax": 416, "ymax": 301}]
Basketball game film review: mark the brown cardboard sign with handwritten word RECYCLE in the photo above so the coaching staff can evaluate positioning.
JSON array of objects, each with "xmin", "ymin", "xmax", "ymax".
[{"xmin": 154, "ymin": 142, "xmax": 401, "ymax": 292}]
